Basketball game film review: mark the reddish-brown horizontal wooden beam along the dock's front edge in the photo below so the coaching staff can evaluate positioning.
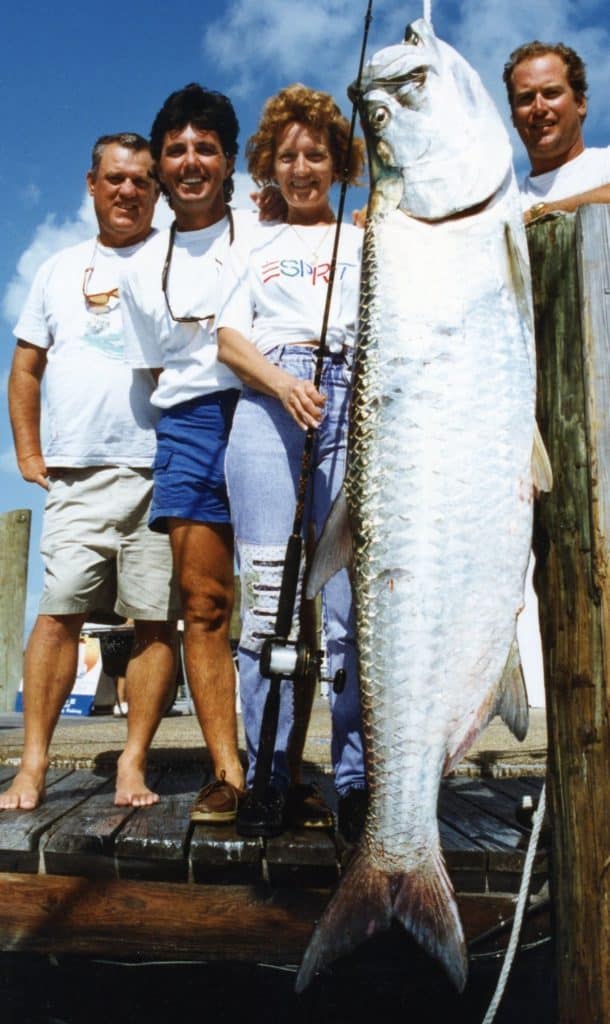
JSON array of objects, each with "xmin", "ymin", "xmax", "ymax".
[{"xmin": 0, "ymin": 873, "xmax": 528, "ymax": 964}]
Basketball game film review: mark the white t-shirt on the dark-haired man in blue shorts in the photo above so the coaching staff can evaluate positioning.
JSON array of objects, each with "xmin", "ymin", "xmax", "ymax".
[{"xmin": 121, "ymin": 210, "xmax": 257, "ymax": 409}]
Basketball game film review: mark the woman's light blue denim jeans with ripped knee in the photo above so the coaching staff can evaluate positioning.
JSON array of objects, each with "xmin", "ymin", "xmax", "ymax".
[{"xmin": 225, "ymin": 345, "xmax": 365, "ymax": 795}]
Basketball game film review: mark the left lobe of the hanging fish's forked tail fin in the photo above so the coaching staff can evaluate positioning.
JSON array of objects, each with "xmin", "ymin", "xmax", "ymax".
[{"xmin": 295, "ymin": 851, "xmax": 392, "ymax": 992}]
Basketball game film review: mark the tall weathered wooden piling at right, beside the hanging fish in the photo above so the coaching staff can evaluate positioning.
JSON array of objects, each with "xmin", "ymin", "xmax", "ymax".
[{"xmin": 528, "ymin": 205, "xmax": 610, "ymax": 1024}]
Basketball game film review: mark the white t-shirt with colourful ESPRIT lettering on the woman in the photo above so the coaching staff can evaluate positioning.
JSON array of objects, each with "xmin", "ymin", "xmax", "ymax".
[{"xmin": 216, "ymin": 222, "xmax": 363, "ymax": 354}]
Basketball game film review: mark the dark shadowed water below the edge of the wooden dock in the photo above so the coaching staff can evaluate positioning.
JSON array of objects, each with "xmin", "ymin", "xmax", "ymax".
[{"xmin": 0, "ymin": 942, "xmax": 556, "ymax": 1024}]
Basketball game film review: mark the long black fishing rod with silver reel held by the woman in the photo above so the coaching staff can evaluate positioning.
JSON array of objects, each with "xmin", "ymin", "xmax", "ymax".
[{"xmin": 253, "ymin": 0, "xmax": 373, "ymax": 800}]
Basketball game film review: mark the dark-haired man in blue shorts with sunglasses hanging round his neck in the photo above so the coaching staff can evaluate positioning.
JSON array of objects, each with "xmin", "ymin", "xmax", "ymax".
[{"xmin": 121, "ymin": 83, "xmax": 257, "ymax": 823}]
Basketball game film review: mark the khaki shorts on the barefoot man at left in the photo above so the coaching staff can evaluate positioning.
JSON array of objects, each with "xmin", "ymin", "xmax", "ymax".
[{"xmin": 39, "ymin": 466, "xmax": 180, "ymax": 622}]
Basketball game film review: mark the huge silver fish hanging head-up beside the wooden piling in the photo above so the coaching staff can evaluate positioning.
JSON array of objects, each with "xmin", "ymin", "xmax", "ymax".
[{"xmin": 297, "ymin": 20, "xmax": 550, "ymax": 990}]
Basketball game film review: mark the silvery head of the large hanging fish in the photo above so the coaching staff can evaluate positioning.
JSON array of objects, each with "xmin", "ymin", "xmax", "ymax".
[{"xmin": 348, "ymin": 18, "xmax": 512, "ymax": 220}]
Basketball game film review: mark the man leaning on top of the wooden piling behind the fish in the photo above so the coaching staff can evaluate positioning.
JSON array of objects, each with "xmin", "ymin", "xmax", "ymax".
[{"xmin": 504, "ymin": 40, "xmax": 610, "ymax": 223}]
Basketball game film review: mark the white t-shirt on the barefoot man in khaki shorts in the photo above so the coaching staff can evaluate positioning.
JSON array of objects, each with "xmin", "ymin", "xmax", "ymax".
[{"xmin": 13, "ymin": 239, "xmax": 158, "ymax": 467}]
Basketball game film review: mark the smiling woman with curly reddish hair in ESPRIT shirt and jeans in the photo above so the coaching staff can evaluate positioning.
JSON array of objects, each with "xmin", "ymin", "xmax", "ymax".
[{"xmin": 216, "ymin": 85, "xmax": 366, "ymax": 840}]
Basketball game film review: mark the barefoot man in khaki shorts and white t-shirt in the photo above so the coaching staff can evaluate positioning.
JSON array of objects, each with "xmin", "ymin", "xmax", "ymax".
[{"xmin": 0, "ymin": 132, "xmax": 179, "ymax": 810}]
